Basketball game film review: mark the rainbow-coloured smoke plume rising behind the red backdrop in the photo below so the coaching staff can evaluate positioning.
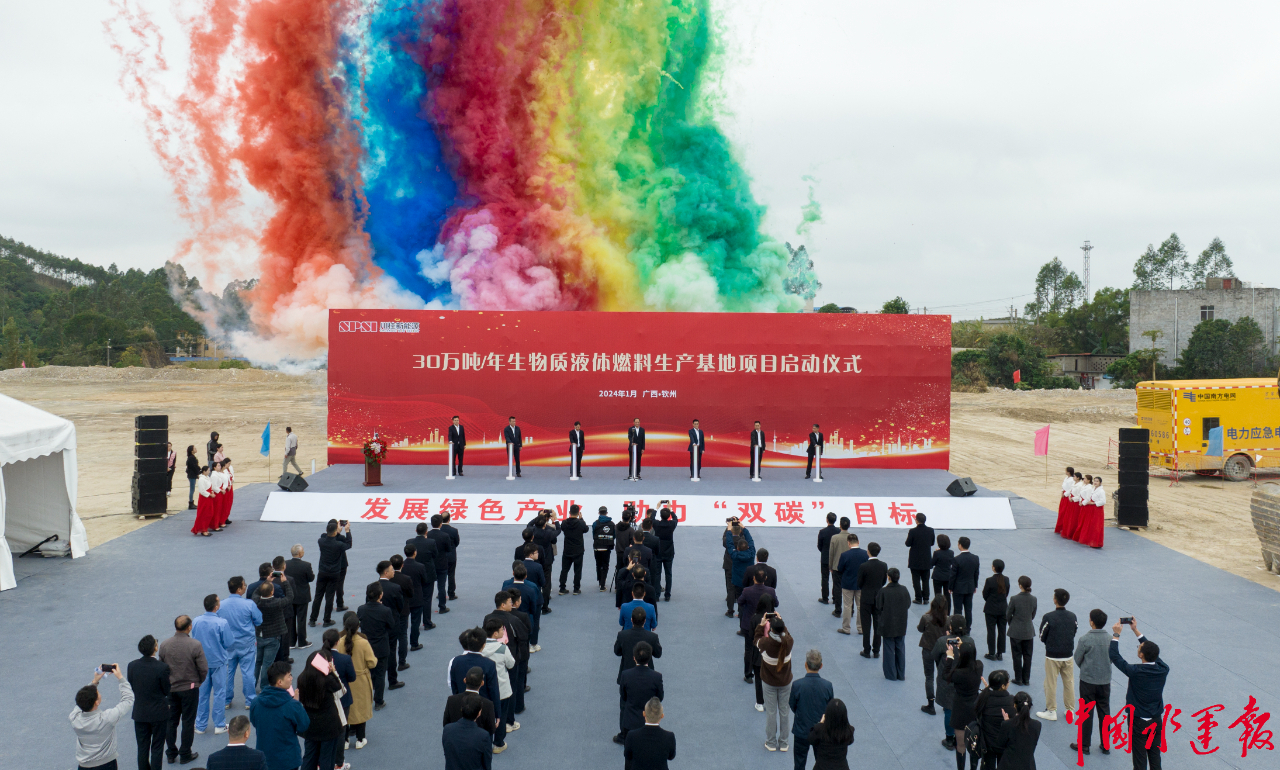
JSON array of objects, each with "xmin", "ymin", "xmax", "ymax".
[{"xmin": 106, "ymin": 0, "xmax": 817, "ymax": 361}]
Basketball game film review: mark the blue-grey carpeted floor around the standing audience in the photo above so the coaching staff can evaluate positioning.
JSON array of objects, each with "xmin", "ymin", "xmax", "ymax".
[{"xmin": 0, "ymin": 468, "xmax": 1280, "ymax": 770}]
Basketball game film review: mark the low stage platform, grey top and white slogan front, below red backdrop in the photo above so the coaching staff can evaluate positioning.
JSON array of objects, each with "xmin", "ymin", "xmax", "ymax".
[{"xmin": 247, "ymin": 466, "xmax": 1015, "ymax": 530}]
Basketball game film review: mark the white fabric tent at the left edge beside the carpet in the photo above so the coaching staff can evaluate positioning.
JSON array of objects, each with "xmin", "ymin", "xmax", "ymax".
[{"xmin": 0, "ymin": 395, "xmax": 88, "ymax": 591}]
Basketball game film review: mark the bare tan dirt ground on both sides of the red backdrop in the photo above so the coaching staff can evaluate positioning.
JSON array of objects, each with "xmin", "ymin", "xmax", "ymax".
[{"xmin": 0, "ymin": 366, "xmax": 1280, "ymax": 590}]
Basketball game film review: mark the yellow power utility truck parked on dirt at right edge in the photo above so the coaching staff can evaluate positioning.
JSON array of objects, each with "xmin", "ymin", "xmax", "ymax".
[{"xmin": 1137, "ymin": 377, "xmax": 1280, "ymax": 481}]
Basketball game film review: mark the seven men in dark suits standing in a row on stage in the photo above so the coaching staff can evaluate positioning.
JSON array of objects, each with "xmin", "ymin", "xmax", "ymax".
[{"xmin": 448, "ymin": 414, "xmax": 826, "ymax": 481}]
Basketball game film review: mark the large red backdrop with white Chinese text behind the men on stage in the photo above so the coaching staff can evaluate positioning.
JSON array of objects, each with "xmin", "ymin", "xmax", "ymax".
[{"xmin": 329, "ymin": 310, "xmax": 951, "ymax": 472}]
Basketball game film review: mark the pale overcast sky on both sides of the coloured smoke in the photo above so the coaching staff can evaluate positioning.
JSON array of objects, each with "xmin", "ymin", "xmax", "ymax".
[{"xmin": 0, "ymin": 0, "xmax": 1280, "ymax": 317}]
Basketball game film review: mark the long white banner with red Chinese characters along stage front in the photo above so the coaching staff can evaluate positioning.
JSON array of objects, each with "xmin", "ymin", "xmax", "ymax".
[{"xmin": 262, "ymin": 491, "xmax": 1016, "ymax": 530}]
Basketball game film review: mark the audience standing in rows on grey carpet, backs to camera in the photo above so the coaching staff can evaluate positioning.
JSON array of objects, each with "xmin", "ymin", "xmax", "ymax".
[{"xmin": 70, "ymin": 491, "xmax": 1169, "ymax": 770}]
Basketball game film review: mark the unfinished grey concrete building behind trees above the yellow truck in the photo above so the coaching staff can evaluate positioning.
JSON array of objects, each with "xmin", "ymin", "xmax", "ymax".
[{"xmin": 1129, "ymin": 278, "xmax": 1280, "ymax": 366}]
